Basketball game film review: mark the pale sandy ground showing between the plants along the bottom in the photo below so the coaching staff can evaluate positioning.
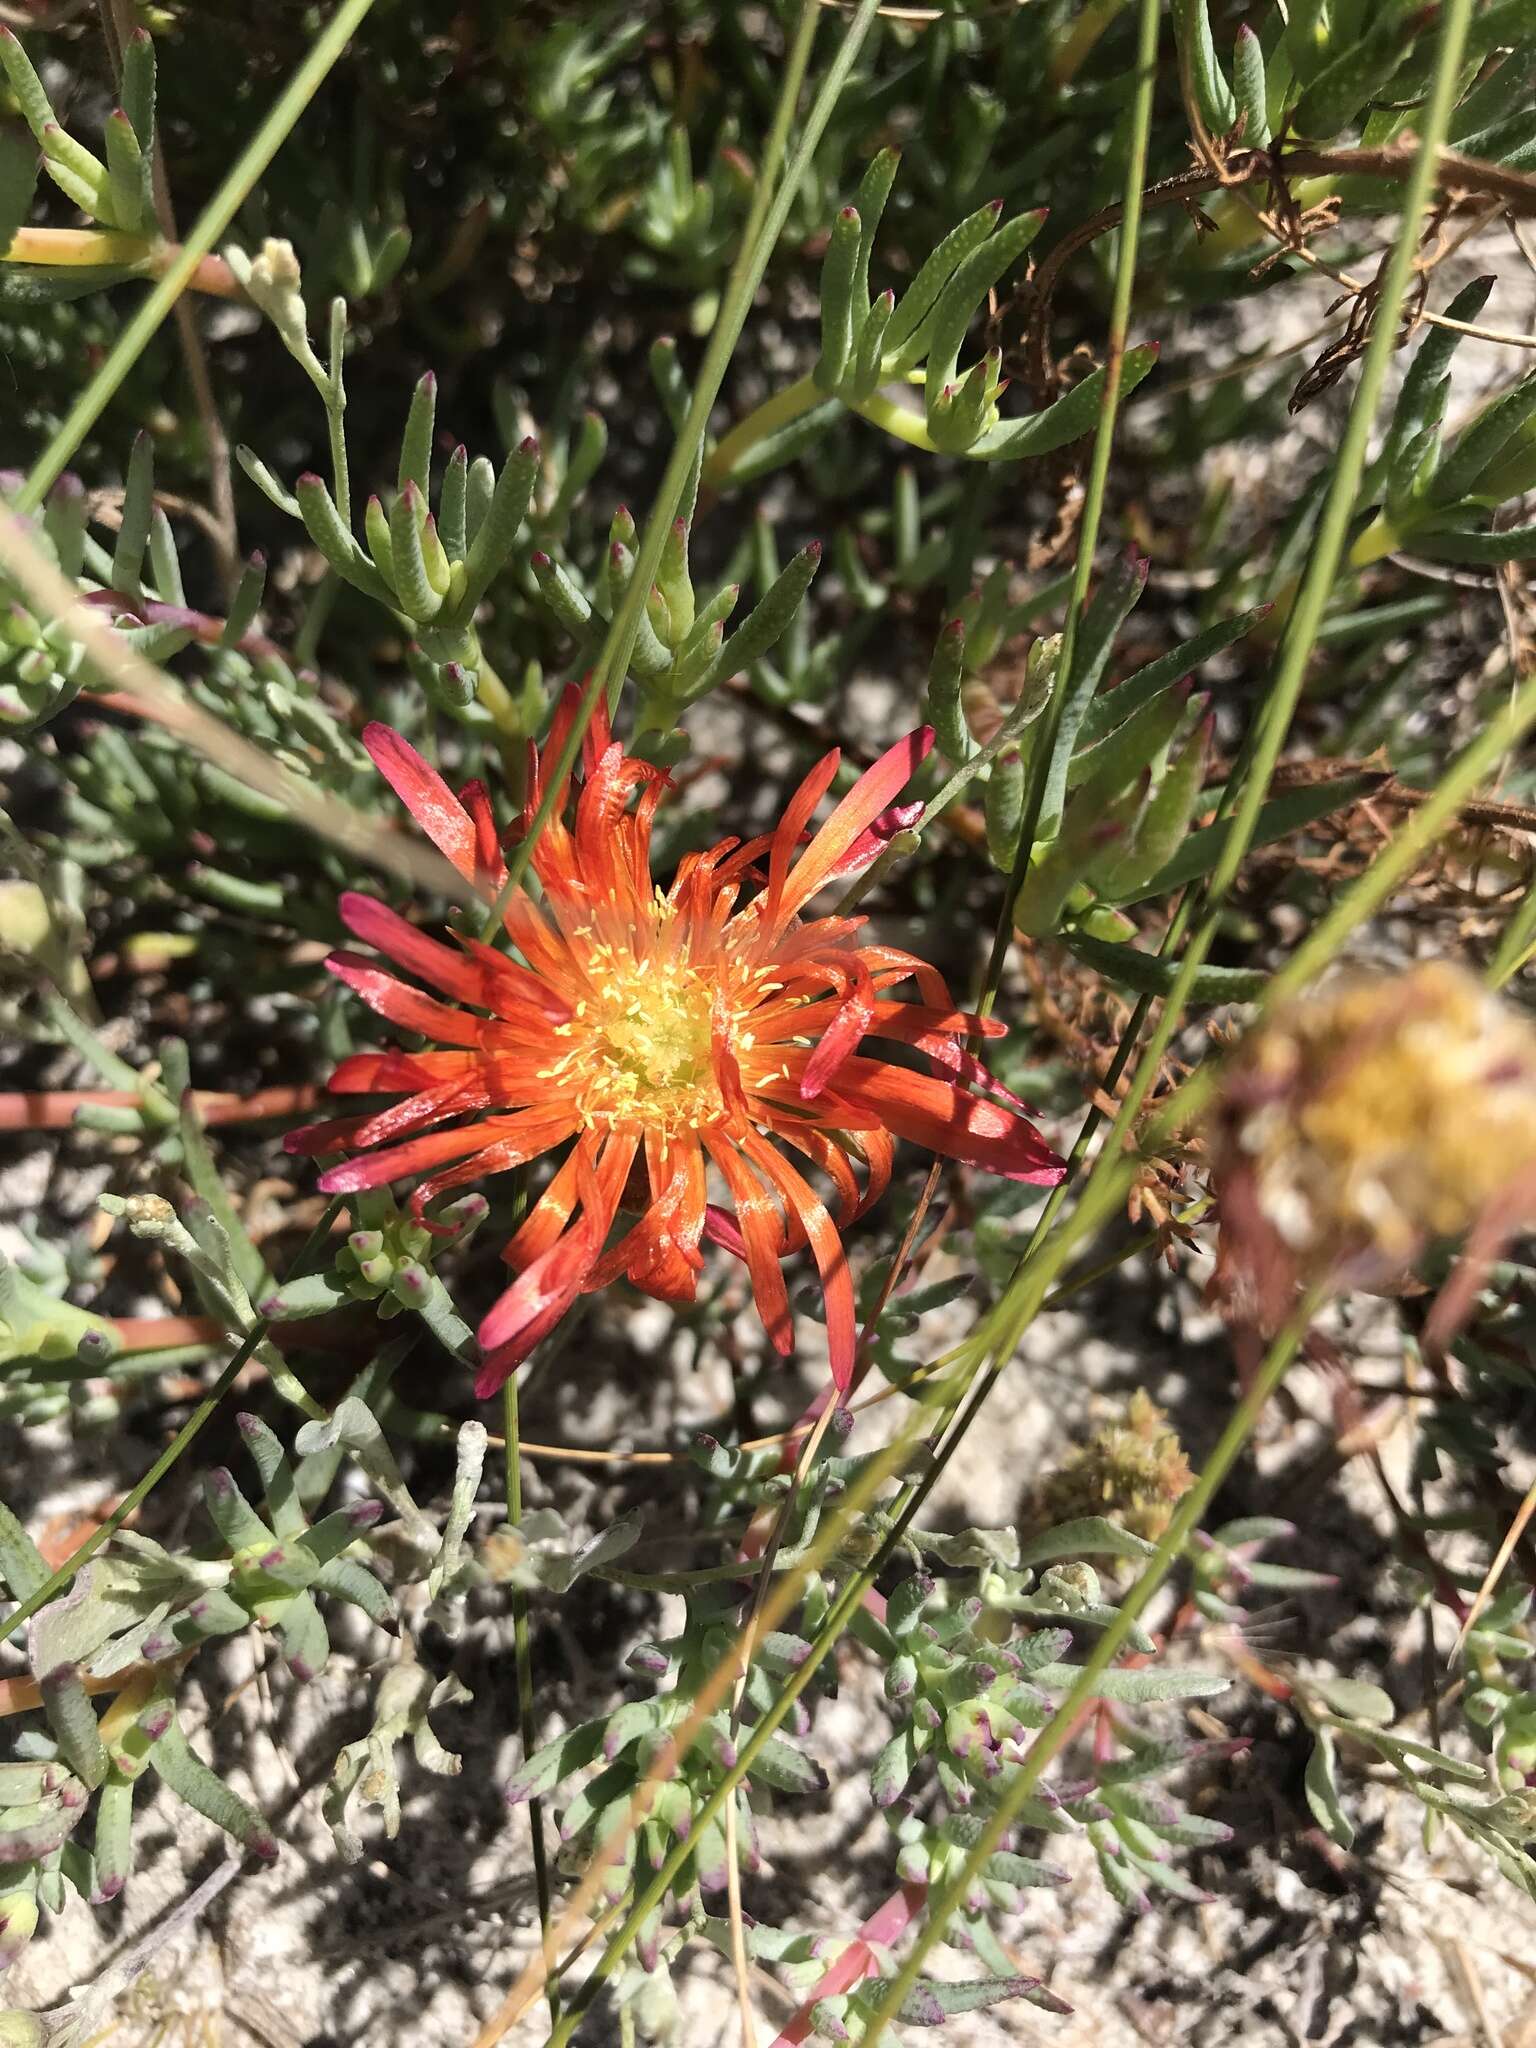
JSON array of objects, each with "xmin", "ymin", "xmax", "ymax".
[{"xmin": 8, "ymin": 1270, "xmax": 1536, "ymax": 2048}]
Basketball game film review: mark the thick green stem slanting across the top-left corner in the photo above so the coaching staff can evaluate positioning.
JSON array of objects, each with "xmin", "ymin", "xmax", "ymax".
[{"xmin": 14, "ymin": 0, "xmax": 373, "ymax": 512}]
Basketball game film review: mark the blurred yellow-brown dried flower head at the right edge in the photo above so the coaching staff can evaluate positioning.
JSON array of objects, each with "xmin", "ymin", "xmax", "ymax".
[{"xmin": 1214, "ymin": 961, "xmax": 1536, "ymax": 1325}]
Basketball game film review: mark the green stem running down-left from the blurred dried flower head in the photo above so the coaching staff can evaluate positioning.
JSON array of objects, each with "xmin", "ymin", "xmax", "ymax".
[{"xmin": 866, "ymin": 1296, "xmax": 1317, "ymax": 2040}]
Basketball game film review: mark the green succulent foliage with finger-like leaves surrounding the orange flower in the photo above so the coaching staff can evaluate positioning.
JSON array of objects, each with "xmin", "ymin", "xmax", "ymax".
[{"xmin": 0, "ymin": 0, "xmax": 1536, "ymax": 2044}]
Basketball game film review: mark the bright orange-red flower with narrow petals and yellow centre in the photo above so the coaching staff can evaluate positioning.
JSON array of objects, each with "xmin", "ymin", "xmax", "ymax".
[{"xmin": 287, "ymin": 690, "xmax": 1063, "ymax": 1399}]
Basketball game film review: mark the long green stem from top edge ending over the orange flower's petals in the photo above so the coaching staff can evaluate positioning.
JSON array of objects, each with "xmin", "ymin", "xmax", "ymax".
[{"xmin": 481, "ymin": 0, "xmax": 879, "ymax": 940}]
